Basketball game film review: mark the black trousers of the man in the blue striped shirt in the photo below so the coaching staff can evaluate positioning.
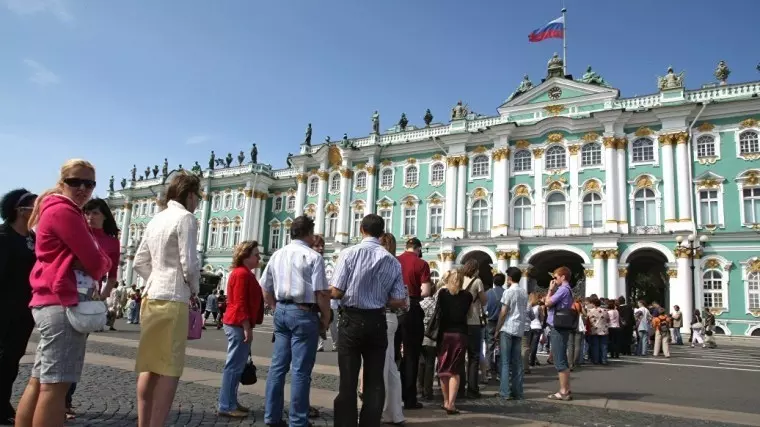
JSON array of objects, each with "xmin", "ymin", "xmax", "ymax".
[{"xmin": 333, "ymin": 307, "xmax": 388, "ymax": 427}]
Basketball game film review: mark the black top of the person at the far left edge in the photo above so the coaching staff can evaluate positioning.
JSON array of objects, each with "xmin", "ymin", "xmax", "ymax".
[{"xmin": 0, "ymin": 224, "xmax": 37, "ymax": 308}]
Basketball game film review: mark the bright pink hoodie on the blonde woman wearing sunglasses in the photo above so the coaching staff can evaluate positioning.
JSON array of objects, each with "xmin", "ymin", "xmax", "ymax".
[{"xmin": 29, "ymin": 194, "xmax": 111, "ymax": 307}]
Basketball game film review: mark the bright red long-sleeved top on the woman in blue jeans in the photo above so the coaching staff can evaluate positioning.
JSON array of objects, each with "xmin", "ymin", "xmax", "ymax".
[{"xmin": 222, "ymin": 266, "xmax": 264, "ymax": 327}]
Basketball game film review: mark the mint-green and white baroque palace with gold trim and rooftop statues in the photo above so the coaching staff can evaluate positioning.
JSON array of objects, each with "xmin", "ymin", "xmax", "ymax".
[{"xmin": 108, "ymin": 55, "xmax": 760, "ymax": 336}]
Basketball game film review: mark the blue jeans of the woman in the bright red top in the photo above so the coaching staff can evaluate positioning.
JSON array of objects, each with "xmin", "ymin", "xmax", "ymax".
[{"xmin": 219, "ymin": 325, "xmax": 251, "ymax": 413}]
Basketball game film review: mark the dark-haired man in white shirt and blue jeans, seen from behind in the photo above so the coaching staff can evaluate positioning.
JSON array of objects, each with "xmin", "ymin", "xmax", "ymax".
[{"xmin": 261, "ymin": 216, "xmax": 330, "ymax": 427}]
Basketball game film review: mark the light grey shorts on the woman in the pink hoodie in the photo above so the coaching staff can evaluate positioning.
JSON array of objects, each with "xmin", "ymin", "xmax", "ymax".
[{"xmin": 32, "ymin": 305, "xmax": 87, "ymax": 384}]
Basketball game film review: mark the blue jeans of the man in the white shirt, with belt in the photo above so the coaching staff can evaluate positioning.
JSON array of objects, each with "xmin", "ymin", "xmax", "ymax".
[{"xmin": 264, "ymin": 304, "xmax": 319, "ymax": 427}]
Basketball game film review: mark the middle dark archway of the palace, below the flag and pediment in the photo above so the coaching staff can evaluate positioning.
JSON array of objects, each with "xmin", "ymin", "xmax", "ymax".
[{"xmin": 528, "ymin": 250, "xmax": 586, "ymax": 297}]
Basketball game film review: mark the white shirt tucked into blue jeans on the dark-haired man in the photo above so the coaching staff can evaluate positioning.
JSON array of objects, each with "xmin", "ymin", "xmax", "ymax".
[{"xmin": 261, "ymin": 240, "xmax": 328, "ymax": 304}]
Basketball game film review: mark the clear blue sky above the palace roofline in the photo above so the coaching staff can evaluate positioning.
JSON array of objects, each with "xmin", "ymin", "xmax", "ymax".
[{"xmin": 0, "ymin": 0, "xmax": 760, "ymax": 195}]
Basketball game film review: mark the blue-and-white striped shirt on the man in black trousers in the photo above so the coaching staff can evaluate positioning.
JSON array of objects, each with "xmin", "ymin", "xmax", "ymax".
[{"xmin": 332, "ymin": 237, "xmax": 406, "ymax": 309}]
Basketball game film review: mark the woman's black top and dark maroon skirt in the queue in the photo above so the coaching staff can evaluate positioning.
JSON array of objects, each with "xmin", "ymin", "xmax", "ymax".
[{"xmin": 438, "ymin": 288, "xmax": 472, "ymax": 378}]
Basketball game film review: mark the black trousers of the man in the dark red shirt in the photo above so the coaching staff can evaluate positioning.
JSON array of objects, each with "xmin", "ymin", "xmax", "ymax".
[{"xmin": 398, "ymin": 301, "xmax": 425, "ymax": 406}]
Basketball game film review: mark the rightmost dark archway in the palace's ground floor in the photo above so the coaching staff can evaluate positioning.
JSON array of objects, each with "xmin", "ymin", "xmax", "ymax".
[{"xmin": 625, "ymin": 248, "xmax": 670, "ymax": 307}]
